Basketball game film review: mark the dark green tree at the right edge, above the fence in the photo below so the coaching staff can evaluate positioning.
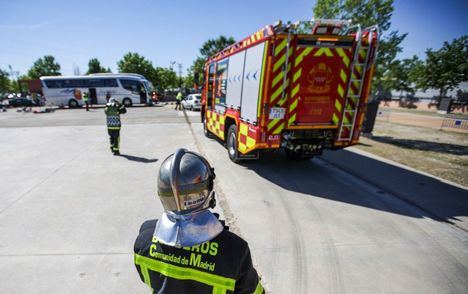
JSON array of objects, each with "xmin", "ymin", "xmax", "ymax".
[{"xmin": 419, "ymin": 35, "xmax": 468, "ymax": 97}]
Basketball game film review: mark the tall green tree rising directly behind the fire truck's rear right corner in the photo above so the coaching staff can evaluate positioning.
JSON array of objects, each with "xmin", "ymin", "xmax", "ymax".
[{"xmin": 313, "ymin": 0, "xmax": 407, "ymax": 93}]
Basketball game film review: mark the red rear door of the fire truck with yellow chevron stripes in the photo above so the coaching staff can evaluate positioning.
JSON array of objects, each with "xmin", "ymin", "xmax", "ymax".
[{"xmin": 288, "ymin": 36, "xmax": 353, "ymax": 127}]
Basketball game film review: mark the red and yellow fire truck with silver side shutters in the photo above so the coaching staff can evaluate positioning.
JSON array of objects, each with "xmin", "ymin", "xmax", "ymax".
[{"xmin": 201, "ymin": 20, "xmax": 378, "ymax": 162}]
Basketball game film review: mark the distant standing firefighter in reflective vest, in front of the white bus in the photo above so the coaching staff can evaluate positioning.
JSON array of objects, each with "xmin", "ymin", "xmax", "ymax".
[{"xmin": 104, "ymin": 93, "xmax": 127, "ymax": 155}]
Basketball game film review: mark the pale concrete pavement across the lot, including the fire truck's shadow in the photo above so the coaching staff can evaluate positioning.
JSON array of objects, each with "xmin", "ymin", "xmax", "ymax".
[{"xmin": 0, "ymin": 106, "xmax": 468, "ymax": 293}]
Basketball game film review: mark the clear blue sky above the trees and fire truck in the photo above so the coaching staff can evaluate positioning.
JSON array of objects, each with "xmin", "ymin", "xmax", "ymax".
[{"xmin": 0, "ymin": 0, "xmax": 468, "ymax": 74}]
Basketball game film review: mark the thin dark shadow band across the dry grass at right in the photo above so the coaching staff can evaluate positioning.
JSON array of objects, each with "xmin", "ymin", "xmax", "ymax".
[{"xmin": 370, "ymin": 136, "xmax": 468, "ymax": 155}]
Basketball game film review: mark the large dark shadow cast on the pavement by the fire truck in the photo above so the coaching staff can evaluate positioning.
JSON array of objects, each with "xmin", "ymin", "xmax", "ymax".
[{"xmin": 245, "ymin": 150, "xmax": 468, "ymax": 230}]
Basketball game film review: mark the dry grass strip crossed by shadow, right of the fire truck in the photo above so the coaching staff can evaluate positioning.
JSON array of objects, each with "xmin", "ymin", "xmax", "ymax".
[{"xmin": 356, "ymin": 121, "xmax": 468, "ymax": 187}]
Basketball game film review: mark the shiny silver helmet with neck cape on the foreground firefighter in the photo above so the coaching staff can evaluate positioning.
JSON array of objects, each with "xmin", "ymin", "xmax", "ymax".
[{"xmin": 154, "ymin": 149, "xmax": 223, "ymax": 247}]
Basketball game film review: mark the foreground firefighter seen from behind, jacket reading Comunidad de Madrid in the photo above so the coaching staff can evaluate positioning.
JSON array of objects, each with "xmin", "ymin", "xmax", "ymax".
[{"xmin": 134, "ymin": 149, "xmax": 265, "ymax": 294}]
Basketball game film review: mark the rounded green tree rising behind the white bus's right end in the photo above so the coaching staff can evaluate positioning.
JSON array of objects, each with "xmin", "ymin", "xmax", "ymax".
[{"xmin": 117, "ymin": 52, "xmax": 157, "ymax": 84}]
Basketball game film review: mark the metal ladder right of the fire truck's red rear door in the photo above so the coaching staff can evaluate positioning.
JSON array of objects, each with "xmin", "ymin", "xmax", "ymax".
[{"xmin": 338, "ymin": 25, "xmax": 377, "ymax": 141}]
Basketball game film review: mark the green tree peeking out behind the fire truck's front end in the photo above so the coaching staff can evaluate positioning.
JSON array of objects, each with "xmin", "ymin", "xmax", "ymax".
[{"xmin": 190, "ymin": 35, "xmax": 236, "ymax": 85}]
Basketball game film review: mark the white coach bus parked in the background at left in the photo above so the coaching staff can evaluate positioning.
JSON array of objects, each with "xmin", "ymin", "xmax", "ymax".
[{"xmin": 41, "ymin": 73, "xmax": 153, "ymax": 108}]
